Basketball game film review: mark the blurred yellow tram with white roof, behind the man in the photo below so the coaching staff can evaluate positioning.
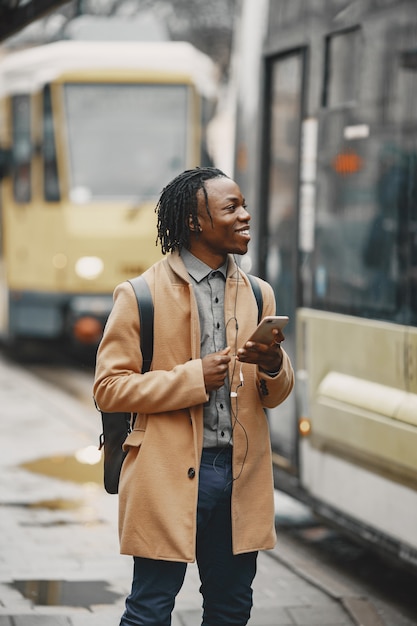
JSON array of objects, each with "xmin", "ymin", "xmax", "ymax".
[{"xmin": 0, "ymin": 41, "xmax": 218, "ymax": 349}]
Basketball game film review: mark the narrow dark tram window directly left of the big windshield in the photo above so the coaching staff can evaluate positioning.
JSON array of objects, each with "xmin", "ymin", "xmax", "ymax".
[{"xmin": 42, "ymin": 85, "xmax": 60, "ymax": 202}]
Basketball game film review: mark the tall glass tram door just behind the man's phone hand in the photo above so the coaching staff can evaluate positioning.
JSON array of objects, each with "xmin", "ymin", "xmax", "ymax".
[{"xmin": 259, "ymin": 50, "xmax": 304, "ymax": 470}]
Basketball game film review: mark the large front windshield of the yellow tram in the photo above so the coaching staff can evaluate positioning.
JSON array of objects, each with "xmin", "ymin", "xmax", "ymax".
[{"xmin": 64, "ymin": 83, "xmax": 189, "ymax": 203}]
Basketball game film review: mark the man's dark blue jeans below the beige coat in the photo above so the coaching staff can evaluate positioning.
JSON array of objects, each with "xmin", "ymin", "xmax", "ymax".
[{"xmin": 120, "ymin": 448, "xmax": 257, "ymax": 626}]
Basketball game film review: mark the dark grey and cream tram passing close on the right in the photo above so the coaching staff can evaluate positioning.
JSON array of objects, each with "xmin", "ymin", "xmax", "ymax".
[{"xmin": 234, "ymin": 0, "xmax": 417, "ymax": 568}]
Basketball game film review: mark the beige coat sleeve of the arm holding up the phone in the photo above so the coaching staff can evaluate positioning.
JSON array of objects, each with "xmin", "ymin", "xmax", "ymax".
[{"xmin": 257, "ymin": 281, "xmax": 294, "ymax": 409}]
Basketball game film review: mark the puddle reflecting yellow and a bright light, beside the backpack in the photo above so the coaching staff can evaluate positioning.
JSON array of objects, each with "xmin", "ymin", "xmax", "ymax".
[{"xmin": 20, "ymin": 446, "xmax": 103, "ymax": 485}]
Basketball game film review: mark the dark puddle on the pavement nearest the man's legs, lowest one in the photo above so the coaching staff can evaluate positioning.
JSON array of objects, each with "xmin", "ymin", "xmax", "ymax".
[{"xmin": 9, "ymin": 580, "xmax": 124, "ymax": 609}]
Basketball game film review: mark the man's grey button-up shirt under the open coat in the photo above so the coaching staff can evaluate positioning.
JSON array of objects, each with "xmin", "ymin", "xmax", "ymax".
[{"xmin": 181, "ymin": 248, "xmax": 232, "ymax": 448}]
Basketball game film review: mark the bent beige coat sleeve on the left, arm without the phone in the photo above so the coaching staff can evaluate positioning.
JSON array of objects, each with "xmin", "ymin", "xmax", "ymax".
[{"xmin": 93, "ymin": 282, "xmax": 207, "ymax": 413}]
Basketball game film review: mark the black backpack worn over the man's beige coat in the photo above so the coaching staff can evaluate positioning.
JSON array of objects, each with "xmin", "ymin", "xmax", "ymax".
[{"xmin": 99, "ymin": 274, "xmax": 263, "ymax": 494}]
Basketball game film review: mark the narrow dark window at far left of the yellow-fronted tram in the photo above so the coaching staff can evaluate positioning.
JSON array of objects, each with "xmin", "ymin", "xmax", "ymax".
[{"xmin": 12, "ymin": 95, "xmax": 32, "ymax": 203}]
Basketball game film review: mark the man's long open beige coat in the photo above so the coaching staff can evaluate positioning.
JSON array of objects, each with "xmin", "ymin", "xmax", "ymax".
[{"xmin": 94, "ymin": 253, "xmax": 293, "ymax": 562}]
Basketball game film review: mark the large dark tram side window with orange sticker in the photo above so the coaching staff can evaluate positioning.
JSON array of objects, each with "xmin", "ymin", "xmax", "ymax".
[{"xmin": 313, "ymin": 41, "xmax": 417, "ymax": 325}]
